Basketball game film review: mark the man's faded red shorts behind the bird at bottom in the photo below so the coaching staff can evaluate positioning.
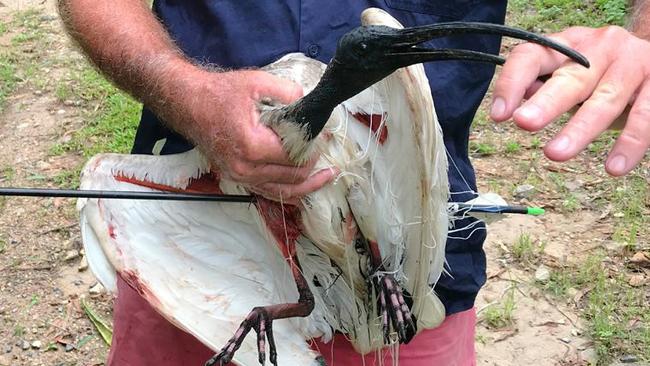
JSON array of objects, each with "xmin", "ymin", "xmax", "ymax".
[{"xmin": 107, "ymin": 277, "xmax": 476, "ymax": 366}]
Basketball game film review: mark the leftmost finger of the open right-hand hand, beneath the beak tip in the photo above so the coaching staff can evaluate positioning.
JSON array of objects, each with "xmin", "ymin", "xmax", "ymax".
[{"xmin": 490, "ymin": 36, "xmax": 571, "ymax": 122}]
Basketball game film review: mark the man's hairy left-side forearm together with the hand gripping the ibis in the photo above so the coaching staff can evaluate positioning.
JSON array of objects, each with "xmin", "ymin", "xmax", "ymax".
[{"xmin": 58, "ymin": 0, "xmax": 334, "ymax": 203}]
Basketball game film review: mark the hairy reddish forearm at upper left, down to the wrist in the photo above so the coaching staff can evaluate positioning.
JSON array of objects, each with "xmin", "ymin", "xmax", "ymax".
[{"xmin": 58, "ymin": 0, "xmax": 204, "ymax": 135}]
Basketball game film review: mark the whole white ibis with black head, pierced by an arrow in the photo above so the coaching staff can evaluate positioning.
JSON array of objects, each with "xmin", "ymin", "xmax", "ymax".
[{"xmin": 78, "ymin": 9, "xmax": 586, "ymax": 365}]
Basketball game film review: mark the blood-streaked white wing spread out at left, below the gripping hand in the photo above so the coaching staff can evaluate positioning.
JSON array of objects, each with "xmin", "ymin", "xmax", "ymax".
[{"xmin": 78, "ymin": 152, "xmax": 316, "ymax": 366}]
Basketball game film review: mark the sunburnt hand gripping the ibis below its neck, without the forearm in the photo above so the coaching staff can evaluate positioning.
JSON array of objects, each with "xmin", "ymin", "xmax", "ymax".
[{"xmin": 181, "ymin": 67, "xmax": 334, "ymax": 203}]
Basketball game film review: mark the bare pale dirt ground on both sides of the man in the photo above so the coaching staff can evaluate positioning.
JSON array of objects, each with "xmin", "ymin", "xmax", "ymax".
[{"xmin": 0, "ymin": 0, "xmax": 650, "ymax": 366}]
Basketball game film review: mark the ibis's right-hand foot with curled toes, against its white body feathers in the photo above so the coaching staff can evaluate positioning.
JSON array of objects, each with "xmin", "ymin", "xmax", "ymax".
[{"xmin": 372, "ymin": 273, "xmax": 417, "ymax": 344}]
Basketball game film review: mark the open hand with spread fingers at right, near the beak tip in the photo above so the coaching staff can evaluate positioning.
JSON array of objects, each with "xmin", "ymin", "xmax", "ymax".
[{"xmin": 490, "ymin": 26, "xmax": 650, "ymax": 176}]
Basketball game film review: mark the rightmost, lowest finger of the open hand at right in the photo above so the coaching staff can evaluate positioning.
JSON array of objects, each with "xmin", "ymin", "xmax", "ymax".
[{"xmin": 605, "ymin": 81, "xmax": 650, "ymax": 176}]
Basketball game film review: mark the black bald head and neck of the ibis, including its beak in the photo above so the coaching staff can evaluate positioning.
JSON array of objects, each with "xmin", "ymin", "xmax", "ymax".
[{"xmin": 284, "ymin": 22, "xmax": 589, "ymax": 152}]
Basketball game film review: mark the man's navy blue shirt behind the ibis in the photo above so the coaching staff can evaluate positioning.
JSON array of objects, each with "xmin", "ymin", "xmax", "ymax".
[{"xmin": 133, "ymin": 0, "xmax": 506, "ymax": 314}]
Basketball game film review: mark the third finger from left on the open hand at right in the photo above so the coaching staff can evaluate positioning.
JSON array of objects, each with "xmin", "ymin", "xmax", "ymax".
[{"xmin": 544, "ymin": 62, "xmax": 643, "ymax": 161}]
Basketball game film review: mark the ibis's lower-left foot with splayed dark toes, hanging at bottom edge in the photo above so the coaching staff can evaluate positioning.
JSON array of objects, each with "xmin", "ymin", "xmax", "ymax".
[{"xmin": 205, "ymin": 307, "xmax": 278, "ymax": 366}]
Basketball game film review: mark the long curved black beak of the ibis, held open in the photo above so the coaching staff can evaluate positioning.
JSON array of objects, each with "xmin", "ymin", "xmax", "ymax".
[{"xmin": 385, "ymin": 22, "xmax": 589, "ymax": 68}]
